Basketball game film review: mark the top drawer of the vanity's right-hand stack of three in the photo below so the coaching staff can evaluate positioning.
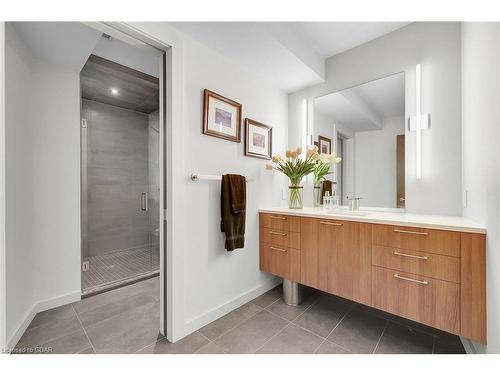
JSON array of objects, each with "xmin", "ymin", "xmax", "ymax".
[{"xmin": 373, "ymin": 224, "xmax": 460, "ymax": 257}]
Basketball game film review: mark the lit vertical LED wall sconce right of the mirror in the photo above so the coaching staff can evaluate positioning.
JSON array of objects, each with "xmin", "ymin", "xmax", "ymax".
[{"xmin": 408, "ymin": 64, "xmax": 431, "ymax": 180}]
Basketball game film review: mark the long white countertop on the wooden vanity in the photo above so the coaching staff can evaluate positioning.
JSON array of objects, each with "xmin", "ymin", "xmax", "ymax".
[{"xmin": 259, "ymin": 207, "xmax": 486, "ymax": 233}]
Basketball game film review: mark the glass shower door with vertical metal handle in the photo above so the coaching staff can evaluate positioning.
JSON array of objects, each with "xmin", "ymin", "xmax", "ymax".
[{"xmin": 82, "ymin": 100, "xmax": 159, "ymax": 294}]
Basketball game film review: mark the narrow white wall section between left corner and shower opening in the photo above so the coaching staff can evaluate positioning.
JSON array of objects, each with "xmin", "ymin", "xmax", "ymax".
[{"xmin": 29, "ymin": 69, "xmax": 81, "ymax": 302}]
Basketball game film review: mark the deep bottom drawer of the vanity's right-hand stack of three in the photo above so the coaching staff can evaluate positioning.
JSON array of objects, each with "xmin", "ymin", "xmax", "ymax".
[{"xmin": 372, "ymin": 266, "xmax": 460, "ymax": 335}]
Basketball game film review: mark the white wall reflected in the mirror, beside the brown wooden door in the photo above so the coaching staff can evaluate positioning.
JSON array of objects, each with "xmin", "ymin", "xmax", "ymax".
[{"xmin": 354, "ymin": 117, "xmax": 405, "ymax": 208}]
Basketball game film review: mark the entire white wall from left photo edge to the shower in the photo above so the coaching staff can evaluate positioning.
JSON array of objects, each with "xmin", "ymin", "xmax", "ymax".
[{"xmin": 6, "ymin": 24, "xmax": 80, "ymax": 341}]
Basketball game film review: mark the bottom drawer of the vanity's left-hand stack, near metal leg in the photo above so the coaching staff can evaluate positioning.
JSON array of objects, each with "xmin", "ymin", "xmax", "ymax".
[{"xmin": 260, "ymin": 243, "xmax": 300, "ymax": 281}]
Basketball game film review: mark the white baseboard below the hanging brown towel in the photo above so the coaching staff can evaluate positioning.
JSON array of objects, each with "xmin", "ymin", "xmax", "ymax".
[{"xmin": 179, "ymin": 278, "xmax": 282, "ymax": 341}]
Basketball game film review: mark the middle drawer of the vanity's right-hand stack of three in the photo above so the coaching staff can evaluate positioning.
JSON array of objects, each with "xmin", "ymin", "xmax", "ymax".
[{"xmin": 372, "ymin": 246, "xmax": 460, "ymax": 283}]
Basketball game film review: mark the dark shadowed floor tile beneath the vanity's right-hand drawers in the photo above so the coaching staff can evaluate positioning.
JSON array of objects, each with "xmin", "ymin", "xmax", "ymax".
[{"xmin": 376, "ymin": 322, "xmax": 434, "ymax": 354}]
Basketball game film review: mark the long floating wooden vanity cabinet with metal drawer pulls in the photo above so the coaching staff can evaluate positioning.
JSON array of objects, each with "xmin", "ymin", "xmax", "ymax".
[{"xmin": 260, "ymin": 213, "xmax": 486, "ymax": 343}]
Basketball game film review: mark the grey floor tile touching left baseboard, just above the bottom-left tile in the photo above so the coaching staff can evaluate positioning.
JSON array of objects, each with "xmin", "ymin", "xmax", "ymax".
[{"xmin": 16, "ymin": 315, "xmax": 82, "ymax": 348}]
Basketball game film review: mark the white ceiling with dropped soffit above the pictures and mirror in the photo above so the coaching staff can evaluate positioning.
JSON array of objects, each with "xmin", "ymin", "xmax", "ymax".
[{"xmin": 169, "ymin": 22, "xmax": 408, "ymax": 92}]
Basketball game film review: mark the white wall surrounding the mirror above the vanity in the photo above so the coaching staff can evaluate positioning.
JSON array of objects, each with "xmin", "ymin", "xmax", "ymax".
[{"xmin": 288, "ymin": 22, "xmax": 461, "ymax": 215}]
